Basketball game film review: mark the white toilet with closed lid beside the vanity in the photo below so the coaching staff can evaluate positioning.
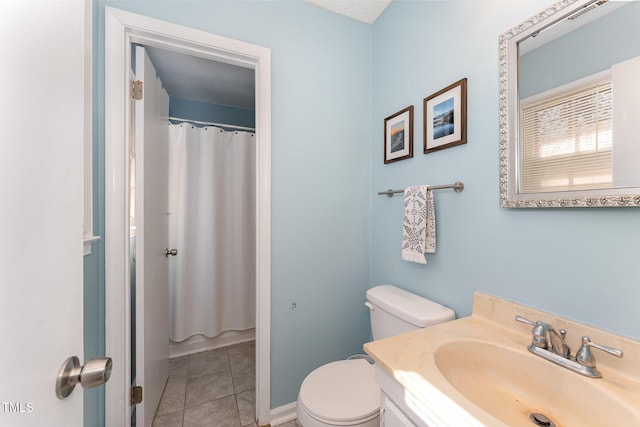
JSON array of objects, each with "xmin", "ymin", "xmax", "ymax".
[{"xmin": 296, "ymin": 285, "xmax": 455, "ymax": 427}]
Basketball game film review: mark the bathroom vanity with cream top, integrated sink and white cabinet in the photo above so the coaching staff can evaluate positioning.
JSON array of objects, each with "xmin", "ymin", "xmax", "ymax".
[{"xmin": 364, "ymin": 293, "xmax": 640, "ymax": 427}]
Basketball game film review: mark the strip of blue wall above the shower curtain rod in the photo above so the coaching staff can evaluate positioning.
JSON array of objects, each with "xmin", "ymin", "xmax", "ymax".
[{"xmin": 169, "ymin": 96, "xmax": 256, "ymax": 128}]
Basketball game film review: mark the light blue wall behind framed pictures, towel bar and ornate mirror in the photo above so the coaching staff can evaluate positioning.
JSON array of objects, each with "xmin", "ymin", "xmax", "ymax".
[{"xmin": 371, "ymin": 0, "xmax": 640, "ymax": 338}]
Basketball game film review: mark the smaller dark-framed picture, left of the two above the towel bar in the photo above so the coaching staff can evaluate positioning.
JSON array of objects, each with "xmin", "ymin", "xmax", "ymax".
[{"xmin": 384, "ymin": 105, "xmax": 413, "ymax": 164}]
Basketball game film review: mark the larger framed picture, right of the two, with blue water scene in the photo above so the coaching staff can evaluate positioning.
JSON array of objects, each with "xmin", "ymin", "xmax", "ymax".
[{"xmin": 423, "ymin": 78, "xmax": 467, "ymax": 154}]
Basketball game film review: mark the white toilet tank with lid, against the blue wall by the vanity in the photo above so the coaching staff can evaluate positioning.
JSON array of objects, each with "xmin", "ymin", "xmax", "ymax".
[{"xmin": 365, "ymin": 285, "xmax": 456, "ymax": 340}]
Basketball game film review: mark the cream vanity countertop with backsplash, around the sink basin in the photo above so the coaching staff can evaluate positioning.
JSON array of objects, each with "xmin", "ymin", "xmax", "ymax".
[{"xmin": 364, "ymin": 293, "xmax": 640, "ymax": 427}]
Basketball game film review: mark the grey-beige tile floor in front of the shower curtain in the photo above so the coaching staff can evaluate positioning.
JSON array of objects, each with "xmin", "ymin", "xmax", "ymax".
[{"xmin": 153, "ymin": 341, "xmax": 296, "ymax": 427}]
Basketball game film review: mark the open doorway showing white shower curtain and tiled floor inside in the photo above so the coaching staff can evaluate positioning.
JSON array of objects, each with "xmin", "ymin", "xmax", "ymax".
[{"xmin": 129, "ymin": 45, "xmax": 256, "ymax": 427}]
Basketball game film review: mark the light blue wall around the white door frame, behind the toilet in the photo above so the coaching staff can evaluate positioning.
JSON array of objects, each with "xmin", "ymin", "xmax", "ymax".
[{"xmin": 96, "ymin": 0, "xmax": 372, "ymax": 407}]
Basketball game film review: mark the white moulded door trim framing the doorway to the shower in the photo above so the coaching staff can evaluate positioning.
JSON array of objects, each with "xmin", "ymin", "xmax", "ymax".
[{"xmin": 105, "ymin": 6, "xmax": 271, "ymax": 427}]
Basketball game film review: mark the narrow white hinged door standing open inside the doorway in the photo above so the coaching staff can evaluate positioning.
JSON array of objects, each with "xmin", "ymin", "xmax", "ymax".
[{"xmin": 135, "ymin": 47, "xmax": 172, "ymax": 427}]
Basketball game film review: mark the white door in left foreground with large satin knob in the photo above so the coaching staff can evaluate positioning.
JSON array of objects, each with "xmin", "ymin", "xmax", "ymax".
[{"xmin": 0, "ymin": 0, "xmax": 85, "ymax": 427}]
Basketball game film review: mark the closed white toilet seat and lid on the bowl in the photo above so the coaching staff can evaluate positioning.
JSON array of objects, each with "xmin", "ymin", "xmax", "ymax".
[{"xmin": 298, "ymin": 359, "xmax": 380, "ymax": 426}]
